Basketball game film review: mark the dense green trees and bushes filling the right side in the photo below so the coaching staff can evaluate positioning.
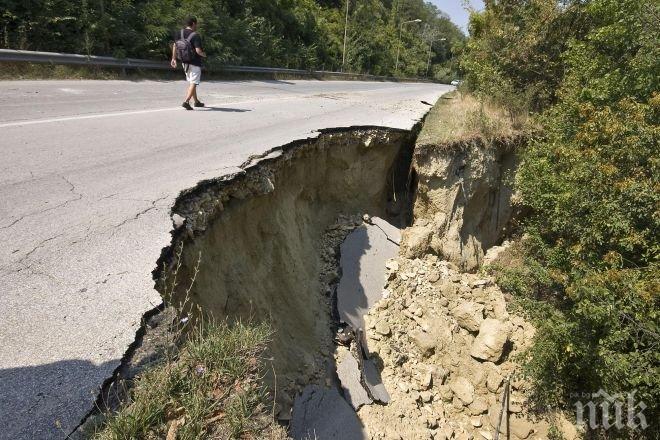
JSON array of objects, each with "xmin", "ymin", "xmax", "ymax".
[{"xmin": 462, "ymin": 0, "xmax": 660, "ymax": 438}]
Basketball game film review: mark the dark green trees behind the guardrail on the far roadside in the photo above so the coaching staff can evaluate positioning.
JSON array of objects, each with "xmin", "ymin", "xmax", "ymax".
[{"xmin": 0, "ymin": 0, "xmax": 465, "ymax": 79}]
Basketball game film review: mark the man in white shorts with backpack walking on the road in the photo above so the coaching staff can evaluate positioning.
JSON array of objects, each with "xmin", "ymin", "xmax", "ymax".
[{"xmin": 170, "ymin": 17, "xmax": 206, "ymax": 110}]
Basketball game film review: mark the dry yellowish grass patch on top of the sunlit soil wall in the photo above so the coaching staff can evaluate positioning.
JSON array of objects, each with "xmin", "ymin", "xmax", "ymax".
[{"xmin": 417, "ymin": 92, "xmax": 528, "ymax": 145}]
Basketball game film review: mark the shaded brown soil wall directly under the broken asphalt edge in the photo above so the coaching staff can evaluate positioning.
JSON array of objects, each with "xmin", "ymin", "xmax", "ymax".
[{"xmin": 155, "ymin": 127, "xmax": 415, "ymax": 406}]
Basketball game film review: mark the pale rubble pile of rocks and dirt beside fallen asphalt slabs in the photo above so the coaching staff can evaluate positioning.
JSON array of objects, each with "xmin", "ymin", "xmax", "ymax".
[{"xmin": 358, "ymin": 255, "xmax": 570, "ymax": 440}]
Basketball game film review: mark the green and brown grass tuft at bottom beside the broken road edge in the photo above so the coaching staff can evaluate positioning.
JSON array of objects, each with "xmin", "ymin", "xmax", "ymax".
[{"xmin": 93, "ymin": 322, "xmax": 285, "ymax": 440}]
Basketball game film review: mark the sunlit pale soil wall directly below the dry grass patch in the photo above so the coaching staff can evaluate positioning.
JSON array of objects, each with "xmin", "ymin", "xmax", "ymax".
[{"xmin": 403, "ymin": 137, "xmax": 524, "ymax": 271}]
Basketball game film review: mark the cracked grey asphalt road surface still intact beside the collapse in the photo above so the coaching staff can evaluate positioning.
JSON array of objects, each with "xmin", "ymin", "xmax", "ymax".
[{"xmin": 0, "ymin": 77, "xmax": 449, "ymax": 439}]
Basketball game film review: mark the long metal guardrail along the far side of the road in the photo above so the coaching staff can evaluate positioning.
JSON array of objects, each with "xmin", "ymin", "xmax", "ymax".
[{"xmin": 0, "ymin": 49, "xmax": 433, "ymax": 82}]
